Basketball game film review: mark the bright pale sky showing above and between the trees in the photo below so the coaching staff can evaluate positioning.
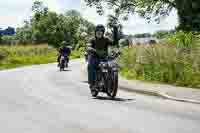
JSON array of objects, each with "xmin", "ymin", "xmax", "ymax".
[{"xmin": 0, "ymin": 0, "xmax": 177, "ymax": 34}]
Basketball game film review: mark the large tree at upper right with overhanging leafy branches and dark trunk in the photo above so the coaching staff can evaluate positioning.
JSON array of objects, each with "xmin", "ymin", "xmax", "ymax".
[{"xmin": 85, "ymin": 0, "xmax": 200, "ymax": 31}]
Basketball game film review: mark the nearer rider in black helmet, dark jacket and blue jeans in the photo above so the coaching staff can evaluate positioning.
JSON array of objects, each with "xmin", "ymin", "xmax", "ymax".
[{"xmin": 87, "ymin": 25, "xmax": 115, "ymax": 89}]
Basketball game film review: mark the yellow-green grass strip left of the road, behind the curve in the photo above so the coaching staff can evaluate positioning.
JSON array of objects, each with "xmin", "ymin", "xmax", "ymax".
[{"xmin": 0, "ymin": 44, "xmax": 57, "ymax": 69}]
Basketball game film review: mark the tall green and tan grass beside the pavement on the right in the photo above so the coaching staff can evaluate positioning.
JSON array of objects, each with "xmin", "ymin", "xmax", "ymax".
[{"xmin": 119, "ymin": 32, "xmax": 200, "ymax": 88}]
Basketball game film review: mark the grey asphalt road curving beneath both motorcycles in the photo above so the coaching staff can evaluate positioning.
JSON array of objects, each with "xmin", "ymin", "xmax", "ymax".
[{"xmin": 0, "ymin": 61, "xmax": 200, "ymax": 133}]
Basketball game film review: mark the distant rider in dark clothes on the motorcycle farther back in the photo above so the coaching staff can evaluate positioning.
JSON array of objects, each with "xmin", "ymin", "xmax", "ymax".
[{"xmin": 57, "ymin": 41, "xmax": 71, "ymax": 66}]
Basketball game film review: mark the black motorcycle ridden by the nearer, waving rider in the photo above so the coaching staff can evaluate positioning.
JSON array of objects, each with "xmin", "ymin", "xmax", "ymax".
[{"xmin": 91, "ymin": 52, "xmax": 119, "ymax": 98}]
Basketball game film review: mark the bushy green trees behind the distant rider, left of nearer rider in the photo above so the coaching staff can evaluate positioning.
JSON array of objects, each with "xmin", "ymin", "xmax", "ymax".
[{"xmin": 17, "ymin": 1, "xmax": 94, "ymax": 48}]
